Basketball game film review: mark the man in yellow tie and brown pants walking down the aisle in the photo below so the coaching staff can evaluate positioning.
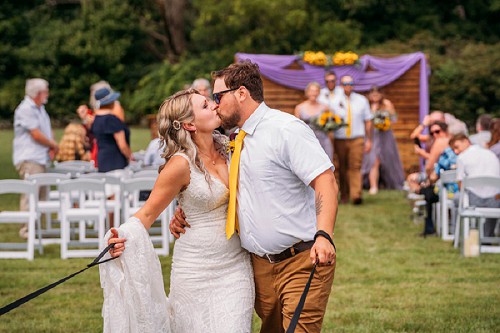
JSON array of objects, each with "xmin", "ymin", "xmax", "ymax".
[{"xmin": 333, "ymin": 75, "xmax": 373, "ymax": 205}]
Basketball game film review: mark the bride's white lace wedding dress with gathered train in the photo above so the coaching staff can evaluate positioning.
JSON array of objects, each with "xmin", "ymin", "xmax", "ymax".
[{"xmin": 100, "ymin": 154, "xmax": 255, "ymax": 333}]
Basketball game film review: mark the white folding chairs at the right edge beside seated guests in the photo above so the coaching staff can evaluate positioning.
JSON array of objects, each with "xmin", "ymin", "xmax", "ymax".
[{"xmin": 433, "ymin": 170, "xmax": 500, "ymax": 254}]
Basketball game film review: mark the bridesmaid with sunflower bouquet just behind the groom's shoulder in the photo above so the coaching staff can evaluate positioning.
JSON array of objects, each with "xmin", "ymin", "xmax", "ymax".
[{"xmin": 294, "ymin": 82, "xmax": 333, "ymax": 161}]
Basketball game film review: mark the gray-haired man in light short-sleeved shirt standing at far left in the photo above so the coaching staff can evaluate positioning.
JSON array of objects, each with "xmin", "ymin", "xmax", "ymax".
[{"xmin": 12, "ymin": 78, "xmax": 59, "ymax": 238}]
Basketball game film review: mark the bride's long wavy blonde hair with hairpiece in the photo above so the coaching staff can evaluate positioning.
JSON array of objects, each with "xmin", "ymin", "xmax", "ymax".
[{"xmin": 157, "ymin": 89, "xmax": 227, "ymax": 176}]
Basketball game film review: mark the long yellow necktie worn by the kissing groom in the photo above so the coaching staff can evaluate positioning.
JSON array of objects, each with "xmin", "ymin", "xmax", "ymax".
[{"xmin": 226, "ymin": 129, "xmax": 247, "ymax": 239}]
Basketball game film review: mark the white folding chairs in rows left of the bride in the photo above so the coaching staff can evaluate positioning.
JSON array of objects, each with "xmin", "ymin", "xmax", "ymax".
[{"xmin": 0, "ymin": 170, "xmax": 175, "ymax": 260}]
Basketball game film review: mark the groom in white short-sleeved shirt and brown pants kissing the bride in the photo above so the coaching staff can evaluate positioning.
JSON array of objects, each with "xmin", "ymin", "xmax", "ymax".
[{"xmin": 170, "ymin": 61, "xmax": 338, "ymax": 332}]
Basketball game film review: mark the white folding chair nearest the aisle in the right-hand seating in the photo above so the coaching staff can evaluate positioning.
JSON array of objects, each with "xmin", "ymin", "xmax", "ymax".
[{"xmin": 436, "ymin": 170, "xmax": 457, "ymax": 241}]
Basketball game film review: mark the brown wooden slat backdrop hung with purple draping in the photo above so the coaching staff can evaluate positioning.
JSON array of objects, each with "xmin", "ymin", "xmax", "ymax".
[{"xmin": 262, "ymin": 63, "xmax": 420, "ymax": 173}]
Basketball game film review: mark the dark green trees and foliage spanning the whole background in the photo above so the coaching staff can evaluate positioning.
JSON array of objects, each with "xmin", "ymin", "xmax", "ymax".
[{"xmin": 0, "ymin": 0, "xmax": 500, "ymax": 124}]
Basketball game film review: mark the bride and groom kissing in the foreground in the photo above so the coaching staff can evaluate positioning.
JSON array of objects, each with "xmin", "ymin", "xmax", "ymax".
[{"xmin": 100, "ymin": 61, "xmax": 338, "ymax": 333}]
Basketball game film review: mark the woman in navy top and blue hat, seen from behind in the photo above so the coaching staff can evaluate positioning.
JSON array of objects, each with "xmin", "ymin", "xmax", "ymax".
[{"xmin": 91, "ymin": 88, "xmax": 132, "ymax": 172}]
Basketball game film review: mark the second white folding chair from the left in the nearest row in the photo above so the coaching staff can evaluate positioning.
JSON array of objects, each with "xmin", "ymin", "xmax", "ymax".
[{"xmin": 59, "ymin": 179, "xmax": 106, "ymax": 259}]
